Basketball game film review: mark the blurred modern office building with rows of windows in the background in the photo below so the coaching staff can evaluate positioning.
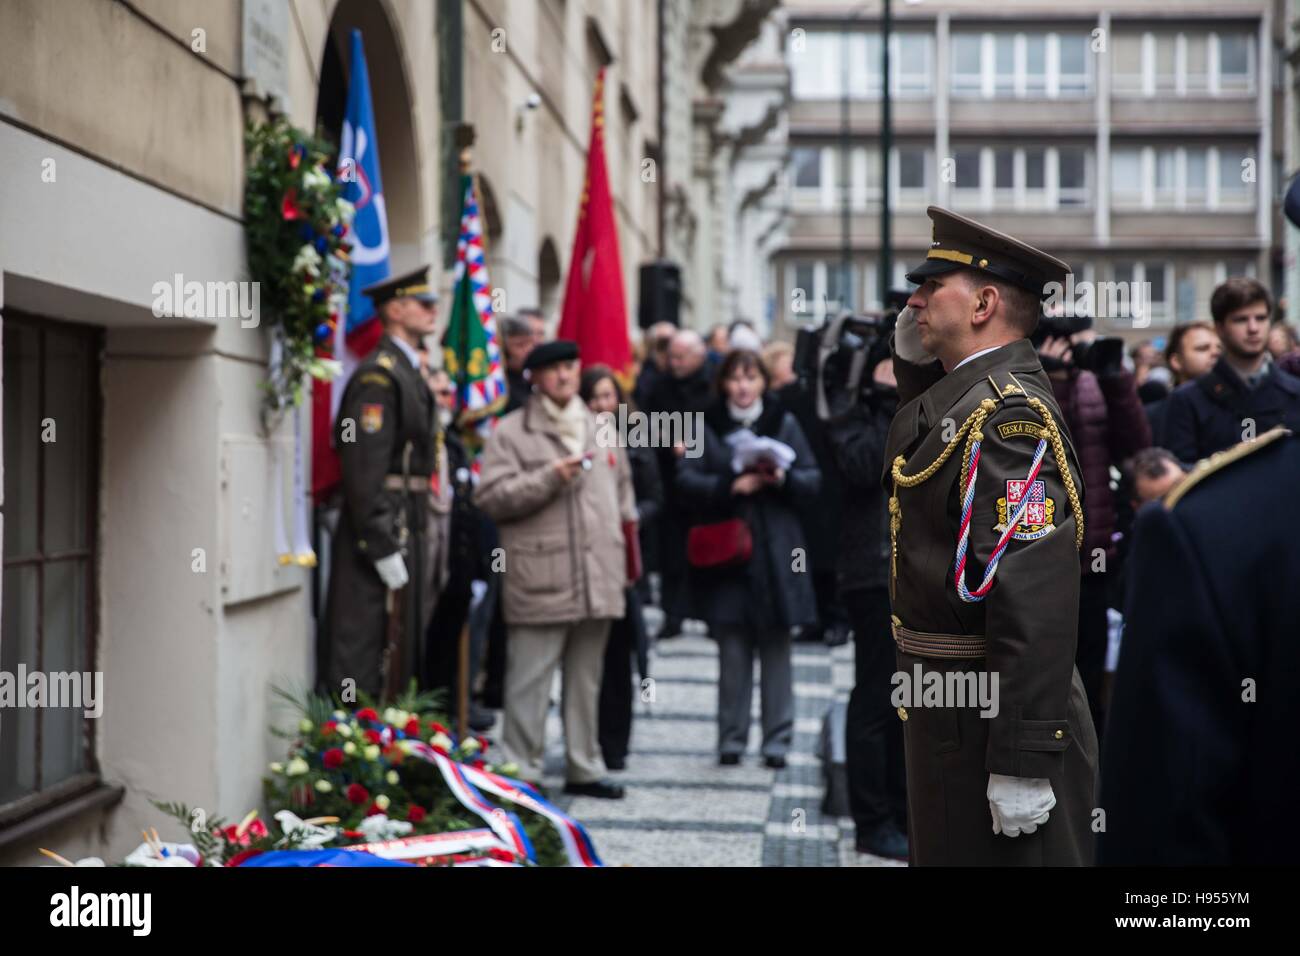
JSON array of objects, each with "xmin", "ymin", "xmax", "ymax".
[{"xmin": 770, "ymin": 0, "xmax": 1287, "ymax": 339}]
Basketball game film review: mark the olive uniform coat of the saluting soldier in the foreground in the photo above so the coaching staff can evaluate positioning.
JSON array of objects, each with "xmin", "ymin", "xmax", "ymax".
[{"xmin": 884, "ymin": 339, "xmax": 1097, "ymax": 866}]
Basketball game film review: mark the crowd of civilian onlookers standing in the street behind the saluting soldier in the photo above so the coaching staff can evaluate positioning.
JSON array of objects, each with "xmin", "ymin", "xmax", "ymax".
[{"xmin": 418, "ymin": 269, "xmax": 1300, "ymax": 856}]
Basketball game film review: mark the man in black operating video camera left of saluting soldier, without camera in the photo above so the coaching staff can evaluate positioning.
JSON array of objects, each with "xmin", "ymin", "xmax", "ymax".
[{"xmin": 826, "ymin": 353, "xmax": 907, "ymax": 860}]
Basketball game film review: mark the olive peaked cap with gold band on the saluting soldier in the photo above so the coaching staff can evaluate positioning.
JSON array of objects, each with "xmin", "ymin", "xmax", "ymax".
[{"xmin": 907, "ymin": 206, "xmax": 1070, "ymax": 299}]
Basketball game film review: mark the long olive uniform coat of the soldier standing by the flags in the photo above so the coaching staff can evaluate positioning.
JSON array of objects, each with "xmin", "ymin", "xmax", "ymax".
[{"xmin": 316, "ymin": 336, "xmax": 438, "ymax": 698}]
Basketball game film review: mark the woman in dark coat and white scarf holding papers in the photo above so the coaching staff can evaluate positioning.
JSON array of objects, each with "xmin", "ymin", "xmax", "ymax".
[{"xmin": 677, "ymin": 349, "xmax": 822, "ymax": 767}]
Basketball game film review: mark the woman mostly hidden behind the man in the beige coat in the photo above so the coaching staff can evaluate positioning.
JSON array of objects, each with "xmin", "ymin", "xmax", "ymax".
[{"xmin": 579, "ymin": 365, "xmax": 663, "ymax": 770}]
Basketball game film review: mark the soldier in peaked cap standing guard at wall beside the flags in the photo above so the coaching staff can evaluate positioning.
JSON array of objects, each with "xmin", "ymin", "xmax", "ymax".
[{"xmin": 316, "ymin": 268, "xmax": 443, "ymax": 697}]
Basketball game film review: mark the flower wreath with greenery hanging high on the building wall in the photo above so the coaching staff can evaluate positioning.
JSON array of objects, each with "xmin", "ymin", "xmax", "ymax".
[{"xmin": 244, "ymin": 117, "xmax": 355, "ymax": 411}]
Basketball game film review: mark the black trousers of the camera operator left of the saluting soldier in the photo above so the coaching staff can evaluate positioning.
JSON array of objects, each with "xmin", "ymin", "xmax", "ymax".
[{"xmin": 844, "ymin": 588, "xmax": 907, "ymax": 834}]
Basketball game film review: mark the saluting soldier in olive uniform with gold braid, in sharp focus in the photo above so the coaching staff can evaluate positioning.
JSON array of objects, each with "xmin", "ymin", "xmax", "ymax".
[{"xmin": 884, "ymin": 207, "xmax": 1097, "ymax": 865}]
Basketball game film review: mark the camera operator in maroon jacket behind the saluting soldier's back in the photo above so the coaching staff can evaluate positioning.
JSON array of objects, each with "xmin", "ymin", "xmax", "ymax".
[{"xmin": 1034, "ymin": 316, "xmax": 1151, "ymax": 736}]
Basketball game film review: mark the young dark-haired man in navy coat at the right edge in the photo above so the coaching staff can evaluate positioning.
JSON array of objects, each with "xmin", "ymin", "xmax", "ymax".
[{"xmin": 1161, "ymin": 276, "xmax": 1300, "ymax": 463}]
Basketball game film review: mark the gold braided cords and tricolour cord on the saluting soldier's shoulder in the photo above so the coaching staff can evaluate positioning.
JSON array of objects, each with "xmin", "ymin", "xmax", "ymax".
[{"xmin": 889, "ymin": 386, "xmax": 1083, "ymax": 604}]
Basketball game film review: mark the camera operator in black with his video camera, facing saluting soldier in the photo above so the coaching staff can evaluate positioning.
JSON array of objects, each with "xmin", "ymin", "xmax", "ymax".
[{"xmin": 796, "ymin": 312, "xmax": 907, "ymax": 860}]
